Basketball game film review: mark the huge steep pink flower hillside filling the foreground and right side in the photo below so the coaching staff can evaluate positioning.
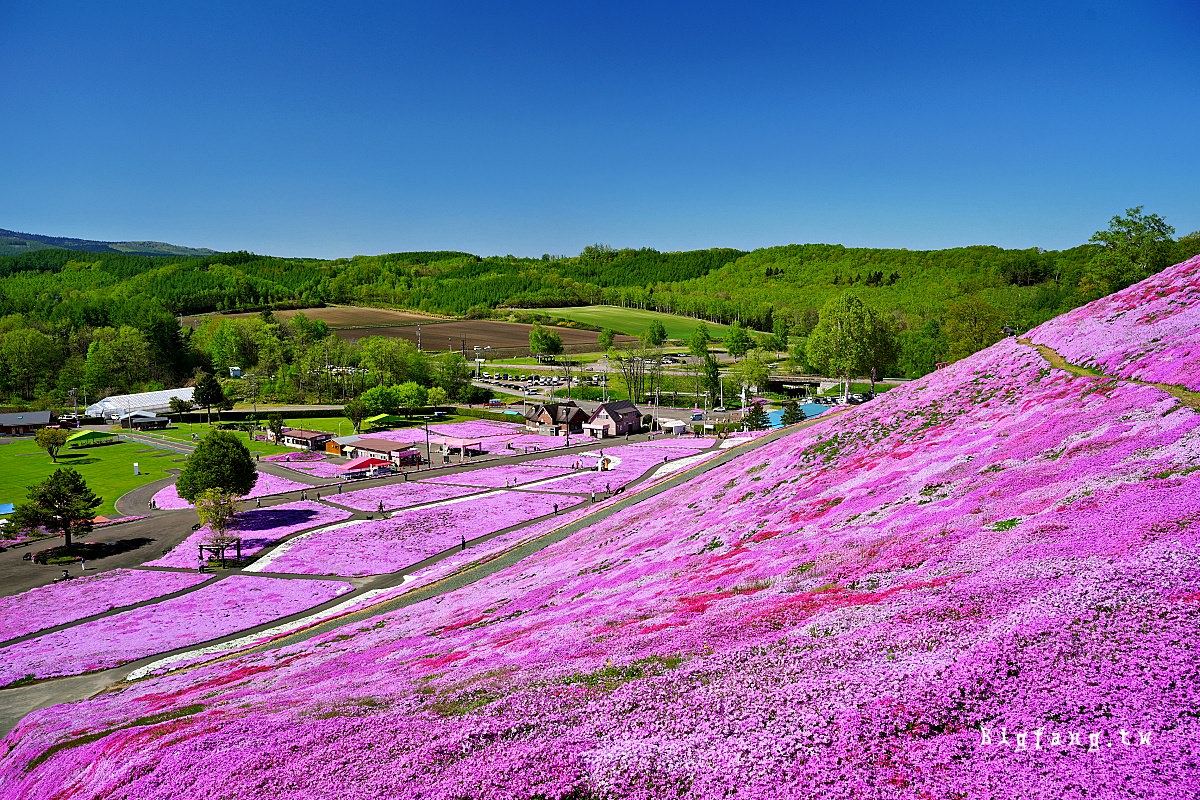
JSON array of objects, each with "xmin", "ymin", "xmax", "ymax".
[{"xmin": 0, "ymin": 262, "xmax": 1200, "ymax": 800}]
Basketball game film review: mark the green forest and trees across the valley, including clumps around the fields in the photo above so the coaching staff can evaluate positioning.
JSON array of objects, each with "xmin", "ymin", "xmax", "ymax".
[{"xmin": 0, "ymin": 207, "xmax": 1200, "ymax": 407}]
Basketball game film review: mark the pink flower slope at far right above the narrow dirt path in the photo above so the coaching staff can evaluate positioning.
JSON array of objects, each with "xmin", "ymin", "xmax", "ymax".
[{"xmin": 1030, "ymin": 250, "xmax": 1200, "ymax": 391}]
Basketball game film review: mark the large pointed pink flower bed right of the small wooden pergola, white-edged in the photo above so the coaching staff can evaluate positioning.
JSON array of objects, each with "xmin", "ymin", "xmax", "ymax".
[{"xmin": 256, "ymin": 491, "xmax": 575, "ymax": 577}]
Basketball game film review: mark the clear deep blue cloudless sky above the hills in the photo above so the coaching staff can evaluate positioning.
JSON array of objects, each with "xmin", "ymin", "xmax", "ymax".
[{"xmin": 0, "ymin": 0, "xmax": 1200, "ymax": 258}]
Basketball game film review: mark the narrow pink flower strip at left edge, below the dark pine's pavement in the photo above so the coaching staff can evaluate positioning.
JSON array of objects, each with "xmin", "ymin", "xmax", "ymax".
[{"xmin": 0, "ymin": 570, "xmax": 212, "ymax": 642}]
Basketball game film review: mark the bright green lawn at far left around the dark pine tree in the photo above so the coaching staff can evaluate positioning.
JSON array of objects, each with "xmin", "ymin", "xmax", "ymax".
[{"xmin": 0, "ymin": 438, "xmax": 184, "ymax": 517}]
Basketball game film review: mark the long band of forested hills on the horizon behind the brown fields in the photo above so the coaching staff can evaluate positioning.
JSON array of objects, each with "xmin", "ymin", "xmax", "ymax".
[{"xmin": 0, "ymin": 236, "xmax": 1200, "ymax": 333}]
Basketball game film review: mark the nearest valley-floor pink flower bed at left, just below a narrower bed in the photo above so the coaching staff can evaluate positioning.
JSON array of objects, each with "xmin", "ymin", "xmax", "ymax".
[{"xmin": 0, "ymin": 575, "xmax": 353, "ymax": 686}]
